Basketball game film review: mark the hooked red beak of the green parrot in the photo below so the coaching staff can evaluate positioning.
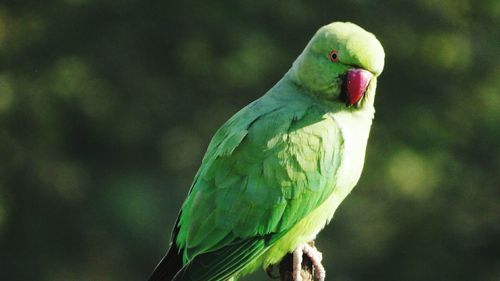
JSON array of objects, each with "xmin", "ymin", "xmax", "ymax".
[{"xmin": 344, "ymin": 68, "xmax": 373, "ymax": 106}]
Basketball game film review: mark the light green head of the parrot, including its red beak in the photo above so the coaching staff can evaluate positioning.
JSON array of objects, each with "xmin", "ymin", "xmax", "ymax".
[{"xmin": 290, "ymin": 22, "xmax": 385, "ymax": 109}]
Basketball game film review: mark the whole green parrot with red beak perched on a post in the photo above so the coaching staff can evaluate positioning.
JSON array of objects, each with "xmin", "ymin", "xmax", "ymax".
[{"xmin": 149, "ymin": 22, "xmax": 385, "ymax": 281}]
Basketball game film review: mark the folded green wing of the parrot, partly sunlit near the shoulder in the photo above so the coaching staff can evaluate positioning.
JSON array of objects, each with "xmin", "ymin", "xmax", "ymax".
[{"xmin": 168, "ymin": 91, "xmax": 343, "ymax": 280}]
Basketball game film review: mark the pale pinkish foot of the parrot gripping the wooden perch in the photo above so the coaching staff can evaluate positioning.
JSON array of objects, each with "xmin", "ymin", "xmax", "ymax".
[{"xmin": 292, "ymin": 243, "xmax": 326, "ymax": 281}]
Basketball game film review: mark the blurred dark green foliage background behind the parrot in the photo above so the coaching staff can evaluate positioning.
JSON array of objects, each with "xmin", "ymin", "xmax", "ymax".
[{"xmin": 0, "ymin": 0, "xmax": 500, "ymax": 281}]
